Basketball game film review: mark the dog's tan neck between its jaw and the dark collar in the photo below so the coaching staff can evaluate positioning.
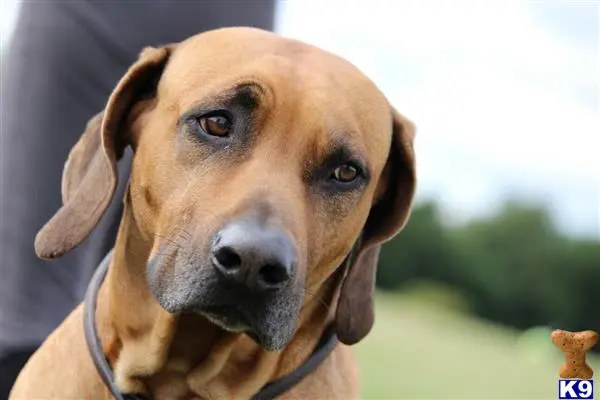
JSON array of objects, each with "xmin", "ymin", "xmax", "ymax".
[{"xmin": 97, "ymin": 202, "xmax": 338, "ymax": 399}]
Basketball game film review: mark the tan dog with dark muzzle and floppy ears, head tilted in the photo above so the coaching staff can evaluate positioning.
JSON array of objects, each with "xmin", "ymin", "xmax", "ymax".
[{"xmin": 11, "ymin": 27, "xmax": 416, "ymax": 400}]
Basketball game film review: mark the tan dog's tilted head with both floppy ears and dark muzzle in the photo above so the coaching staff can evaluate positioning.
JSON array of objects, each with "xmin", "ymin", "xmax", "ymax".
[{"xmin": 36, "ymin": 28, "xmax": 415, "ymax": 350}]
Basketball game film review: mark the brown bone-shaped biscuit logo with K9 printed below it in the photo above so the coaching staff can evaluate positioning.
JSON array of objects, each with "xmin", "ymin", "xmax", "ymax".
[{"xmin": 551, "ymin": 329, "xmax": 599, "ymax": 400}]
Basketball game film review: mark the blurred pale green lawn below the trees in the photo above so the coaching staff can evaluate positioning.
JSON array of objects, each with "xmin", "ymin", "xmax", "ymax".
[{"xmin": 355, "ymin": 293, "xmax": 600, "ymax": 399}]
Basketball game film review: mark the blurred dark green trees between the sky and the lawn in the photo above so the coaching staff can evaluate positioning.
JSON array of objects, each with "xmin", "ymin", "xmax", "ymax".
[{"xmin": 377, "ymin": 201, "xmax": 600, "ymax": 350}]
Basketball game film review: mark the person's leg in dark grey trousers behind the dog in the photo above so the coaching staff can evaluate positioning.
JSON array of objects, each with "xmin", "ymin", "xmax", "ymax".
[{"xmin": 0, "ymin": 0, "xmax": 274, "ymax": 399}]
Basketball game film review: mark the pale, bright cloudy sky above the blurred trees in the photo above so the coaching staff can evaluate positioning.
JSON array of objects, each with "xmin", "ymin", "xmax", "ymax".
[{"xmin": 0, "ymin": 0, "xmax": 600, "ymax": 238}]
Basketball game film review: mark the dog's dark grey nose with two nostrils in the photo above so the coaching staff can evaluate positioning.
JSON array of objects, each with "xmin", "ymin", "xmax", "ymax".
[{"xmin": 212, "ymin": 222, "xmax": 296, "ymax": 292}]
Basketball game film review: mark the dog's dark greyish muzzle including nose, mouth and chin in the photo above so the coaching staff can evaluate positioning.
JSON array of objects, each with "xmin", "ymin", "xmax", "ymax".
[{"xmin": 147, "ymin": 217, "xmax": 304, "ymax": 350}]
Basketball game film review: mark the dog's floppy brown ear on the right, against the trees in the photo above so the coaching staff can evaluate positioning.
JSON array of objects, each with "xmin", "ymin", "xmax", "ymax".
[{"xmin": 335, "ymin": 109, "xmax": 416, "ymax": 345}]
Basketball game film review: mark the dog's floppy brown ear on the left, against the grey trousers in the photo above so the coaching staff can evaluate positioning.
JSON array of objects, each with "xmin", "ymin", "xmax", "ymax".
[{"xmin": 35, "ymin": 46, "xmax": 174, "ymax": 258}]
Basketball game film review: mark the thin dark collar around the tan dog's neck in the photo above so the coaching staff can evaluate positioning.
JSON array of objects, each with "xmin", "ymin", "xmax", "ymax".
[{"xmin": 83, "ymin": 250, "xmax": 344, "ymax": 400}]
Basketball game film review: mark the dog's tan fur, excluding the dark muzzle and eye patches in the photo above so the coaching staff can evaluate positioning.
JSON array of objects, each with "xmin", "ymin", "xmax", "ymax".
[{"xmin": 11, "ymin": 28, "xmax": 415, "ymax": 400}]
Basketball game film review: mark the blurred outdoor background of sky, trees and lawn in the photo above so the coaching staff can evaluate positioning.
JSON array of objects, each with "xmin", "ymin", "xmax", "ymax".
[{"xmin": 0, "ymin": 0, "xmax": 600, "ymax": 399}]
